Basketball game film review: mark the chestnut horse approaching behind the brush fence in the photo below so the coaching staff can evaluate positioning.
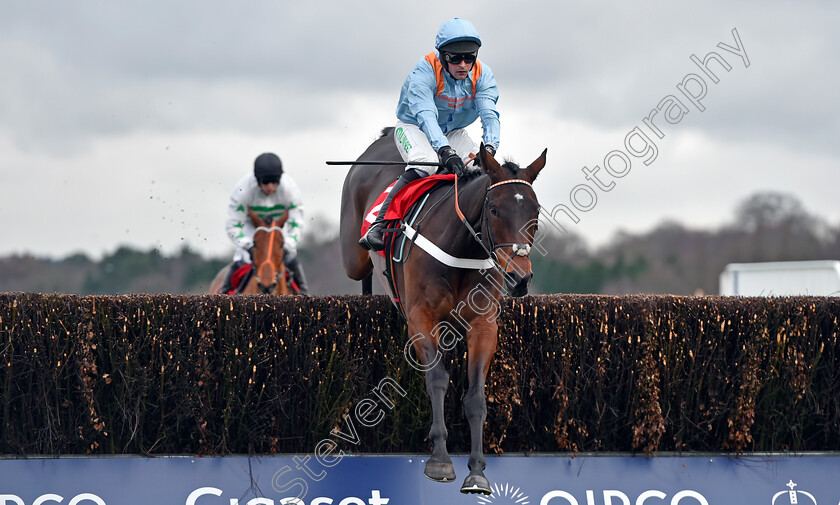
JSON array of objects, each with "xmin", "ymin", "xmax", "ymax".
[{"xmin": 210, "ymin": 210, "xmax": 289, "ymax": 295}]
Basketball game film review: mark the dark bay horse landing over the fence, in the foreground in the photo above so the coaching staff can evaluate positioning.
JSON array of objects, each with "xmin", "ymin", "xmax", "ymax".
[{"xmin": 340, "ymin": 128, "xmax": 547, "ymax": 494}]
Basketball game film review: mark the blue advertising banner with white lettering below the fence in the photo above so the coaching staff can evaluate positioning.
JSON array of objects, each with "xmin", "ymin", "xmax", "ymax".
[{"xmin": 0, "ymin": 455, "xmax": 840, "ymax": 505}]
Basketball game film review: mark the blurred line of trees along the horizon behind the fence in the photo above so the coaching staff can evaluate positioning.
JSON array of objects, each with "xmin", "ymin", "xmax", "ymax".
[{"xmin": 0, "ymin": 193, "xmax": 840, "ymax": 295}]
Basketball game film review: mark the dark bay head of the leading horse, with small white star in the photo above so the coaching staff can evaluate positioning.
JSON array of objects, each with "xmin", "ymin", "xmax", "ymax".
[{"xmin": 479, "ymin": 145, "xmax": 548, "ymax": 296}]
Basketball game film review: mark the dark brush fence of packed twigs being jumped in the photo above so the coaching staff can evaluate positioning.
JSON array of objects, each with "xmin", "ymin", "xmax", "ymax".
[{"xmin": 0, "ymin": 293, "xmax": 840, "ymax": 455}]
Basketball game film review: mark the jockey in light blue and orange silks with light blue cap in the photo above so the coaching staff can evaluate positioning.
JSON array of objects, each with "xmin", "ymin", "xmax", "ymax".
[{"xmin": 359, "ymin": 18, "xmax": 500, "ymax": 251}]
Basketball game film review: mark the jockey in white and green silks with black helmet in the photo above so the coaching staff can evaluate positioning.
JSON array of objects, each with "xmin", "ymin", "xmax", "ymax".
[{"xmin": 222, "ymin": 153, "xmax": 308, "ymax": 294}]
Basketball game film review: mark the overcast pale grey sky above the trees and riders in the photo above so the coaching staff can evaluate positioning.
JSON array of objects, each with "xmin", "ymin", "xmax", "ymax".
[{"xmin": 0, "ymin": 0, "xmax": 840, "ymax": 258}]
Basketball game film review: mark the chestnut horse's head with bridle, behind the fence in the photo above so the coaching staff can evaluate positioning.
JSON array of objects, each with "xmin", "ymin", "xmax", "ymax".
[{"xmin": 248, "ymin": 210, "xmax": 289, "ymax": 294}]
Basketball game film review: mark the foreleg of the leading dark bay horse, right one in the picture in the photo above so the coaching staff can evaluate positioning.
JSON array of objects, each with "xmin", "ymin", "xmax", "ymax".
[{"xmin": 461, "ymin": 324, "xmax": 498, "ymax": 494}]
